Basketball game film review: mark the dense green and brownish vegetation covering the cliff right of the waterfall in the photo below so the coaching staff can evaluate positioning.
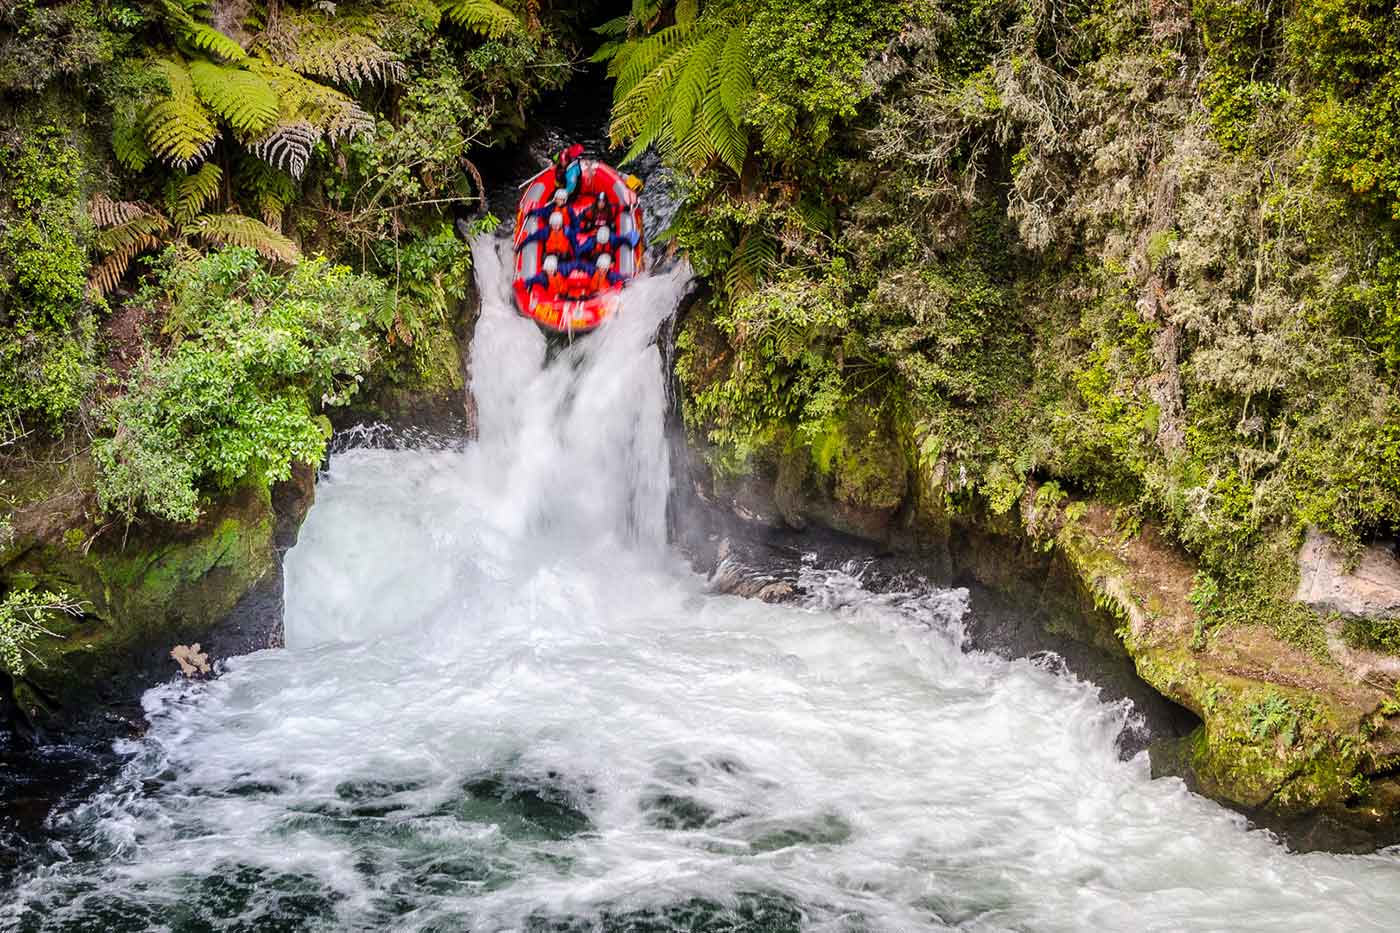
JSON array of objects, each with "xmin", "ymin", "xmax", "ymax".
[{"xmin": 593, "ymin": 0, "xmax": 1400, "ymax": 649}]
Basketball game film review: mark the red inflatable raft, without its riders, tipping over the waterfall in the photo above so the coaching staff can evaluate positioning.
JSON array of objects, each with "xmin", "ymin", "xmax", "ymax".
[{"xmin": 514, "ymin": 160, "xmax": 644, "ymax": 333}]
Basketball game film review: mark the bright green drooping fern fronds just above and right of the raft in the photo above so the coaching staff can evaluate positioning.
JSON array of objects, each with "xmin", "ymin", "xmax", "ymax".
[{"xmin": 609, "ymin": 14, "xmax": 753, "ymax": 172}]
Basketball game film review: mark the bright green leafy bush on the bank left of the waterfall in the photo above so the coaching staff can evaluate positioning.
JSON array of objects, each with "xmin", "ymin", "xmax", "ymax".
[{"xmin": 92, "ymin": 248, "xmax": 385, "ymax": 521}]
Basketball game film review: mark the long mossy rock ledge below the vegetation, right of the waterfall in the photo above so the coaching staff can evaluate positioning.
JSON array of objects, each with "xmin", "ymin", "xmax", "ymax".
[{"xmin": 685, "ymin": 308, "xmax": 1400, "ymax": 850}]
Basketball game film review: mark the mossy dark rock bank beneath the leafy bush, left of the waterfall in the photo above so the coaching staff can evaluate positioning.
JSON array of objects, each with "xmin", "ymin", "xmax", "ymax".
[{"xmin": 0, "ymin": 457, "xmax": 314, "ymax": 733}]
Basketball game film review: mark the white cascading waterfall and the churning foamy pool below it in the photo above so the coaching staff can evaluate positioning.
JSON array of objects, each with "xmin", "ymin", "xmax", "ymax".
[{"xmin": 8, "ymin": 240, "xmax": 1400, "ymax": 933}]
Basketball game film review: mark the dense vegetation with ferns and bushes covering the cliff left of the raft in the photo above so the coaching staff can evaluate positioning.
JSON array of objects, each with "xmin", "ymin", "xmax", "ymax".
[{"xmin": 0, "ymin": 0, "xmax": 599, "ymax": 674}]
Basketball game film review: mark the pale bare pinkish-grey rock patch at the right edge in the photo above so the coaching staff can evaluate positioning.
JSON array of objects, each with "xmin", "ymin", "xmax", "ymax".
[{"xmin": 1294, "ymin": 530, "xmax": 1400, "ymax": 618}]
